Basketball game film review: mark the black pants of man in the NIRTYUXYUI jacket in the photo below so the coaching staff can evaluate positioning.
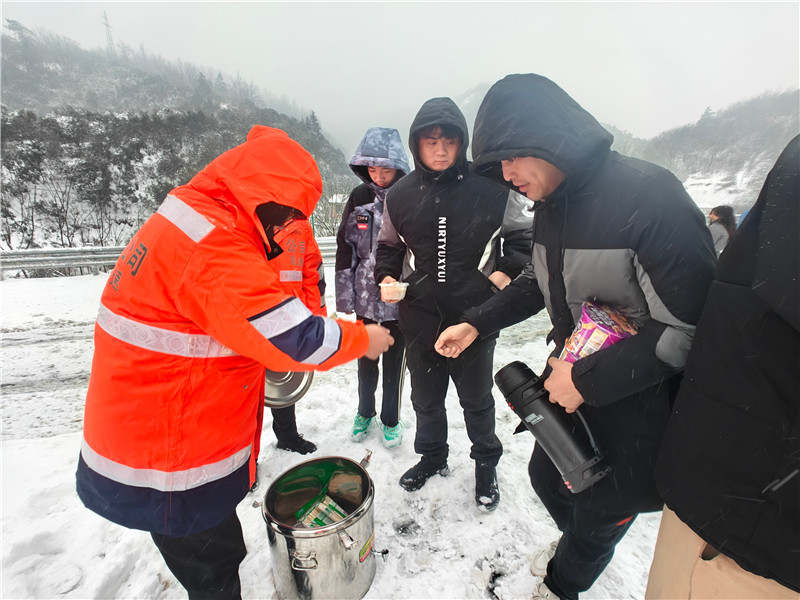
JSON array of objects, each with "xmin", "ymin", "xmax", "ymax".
[{"xmin": 406, "ymin": 338, "xmax": 503, "ymax": 465}]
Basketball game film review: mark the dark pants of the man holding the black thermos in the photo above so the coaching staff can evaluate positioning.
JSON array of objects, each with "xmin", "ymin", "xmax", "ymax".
[{"xmin": 528, "ymin": 446, "xmax": 636, "ymax": 600}]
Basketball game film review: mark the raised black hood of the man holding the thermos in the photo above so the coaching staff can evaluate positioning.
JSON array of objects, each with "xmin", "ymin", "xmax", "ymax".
[{"xmin": 472, "ymin": 73, "xmax": 614, "ymax": 191}]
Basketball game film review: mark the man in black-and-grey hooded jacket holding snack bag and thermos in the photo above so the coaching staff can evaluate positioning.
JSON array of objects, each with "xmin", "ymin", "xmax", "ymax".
[{"xmin": 436, "ymin": 74, "xmax": 715, "ymax": 598}]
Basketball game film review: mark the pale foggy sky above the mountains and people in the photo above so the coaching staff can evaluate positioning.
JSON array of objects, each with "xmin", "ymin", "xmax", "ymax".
[{"xmin": 2, "ymin": 1, "xmax": 800, "ymax": 158}]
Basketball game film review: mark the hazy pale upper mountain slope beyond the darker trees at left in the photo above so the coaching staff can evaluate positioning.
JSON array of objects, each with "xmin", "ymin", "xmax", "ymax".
[{"xmin": 0, "ymin": 19, "xmax": 354, "ymax": 188}]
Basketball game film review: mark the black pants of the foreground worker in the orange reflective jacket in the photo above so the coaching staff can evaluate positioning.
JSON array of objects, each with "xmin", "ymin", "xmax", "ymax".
[{"xmin": 150, "ymin": 512, "xmax": 247, "ymax": 600}]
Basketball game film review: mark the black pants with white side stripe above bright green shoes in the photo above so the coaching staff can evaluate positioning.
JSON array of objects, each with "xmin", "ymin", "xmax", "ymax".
[{"xmin": 358, "ymin": 317, "xmax": 406, "ymax": 427}]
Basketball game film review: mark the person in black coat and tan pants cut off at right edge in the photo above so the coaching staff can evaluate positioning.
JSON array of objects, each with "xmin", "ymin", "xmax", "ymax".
[{"xmin": 645, "ymin": 136, "xmax": 800, "ymax": 600}]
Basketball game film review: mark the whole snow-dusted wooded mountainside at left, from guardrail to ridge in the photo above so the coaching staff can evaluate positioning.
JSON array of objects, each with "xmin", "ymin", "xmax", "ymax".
[{"xmin": 0, "ymin": 19, "xmax": 358, "ymax": 248}]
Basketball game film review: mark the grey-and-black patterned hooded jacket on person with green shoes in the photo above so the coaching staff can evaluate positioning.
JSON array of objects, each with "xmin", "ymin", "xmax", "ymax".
[{"xmin": 335, "ymin": 127, "xmax": 411, "ymax": 323}]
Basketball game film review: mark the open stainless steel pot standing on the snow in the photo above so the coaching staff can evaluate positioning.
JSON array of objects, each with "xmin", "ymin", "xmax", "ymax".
[{"xmin": 261, "ymin": 454, "xmax": 375, "ymax": 600}]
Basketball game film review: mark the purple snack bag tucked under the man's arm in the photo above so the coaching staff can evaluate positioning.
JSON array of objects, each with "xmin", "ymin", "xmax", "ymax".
[{"xmin": 559, "ymin": 302, "xmax": 636, "ymax": 363}]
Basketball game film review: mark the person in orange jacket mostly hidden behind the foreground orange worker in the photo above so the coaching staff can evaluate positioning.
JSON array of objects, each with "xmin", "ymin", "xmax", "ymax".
[{"xmin": 262, "ymin": 208, "xmax": 324, "ymax": 454}]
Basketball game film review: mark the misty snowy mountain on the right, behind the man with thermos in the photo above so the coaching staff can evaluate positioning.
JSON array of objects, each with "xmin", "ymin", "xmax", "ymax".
[{"xmin": 454, "ymin": 84, "xmax": 800, "ymax": 213}]
